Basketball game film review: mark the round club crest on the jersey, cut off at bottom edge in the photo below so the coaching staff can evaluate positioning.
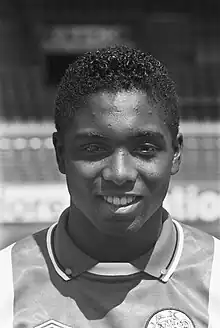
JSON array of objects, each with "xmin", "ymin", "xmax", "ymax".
[{"xmin": 145, "ymin": 309, "xmax": 195, "ymax": 328}]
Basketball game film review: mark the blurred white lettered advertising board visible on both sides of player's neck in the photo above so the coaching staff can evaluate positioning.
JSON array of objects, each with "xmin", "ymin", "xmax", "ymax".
[{"xmin": 0, "ymin": 181, "xmax": 220, "ymax": 238}]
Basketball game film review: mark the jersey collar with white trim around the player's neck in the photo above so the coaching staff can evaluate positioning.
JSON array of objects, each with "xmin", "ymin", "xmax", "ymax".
[{"xmin": 47, "ymin": 209, "xmax": 183, "ymax": 282}]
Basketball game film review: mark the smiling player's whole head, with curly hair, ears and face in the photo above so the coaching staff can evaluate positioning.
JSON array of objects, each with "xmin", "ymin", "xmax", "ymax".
[{"xmin": 53, "ymin": 46, "xmax": 182, "ymax": 235}]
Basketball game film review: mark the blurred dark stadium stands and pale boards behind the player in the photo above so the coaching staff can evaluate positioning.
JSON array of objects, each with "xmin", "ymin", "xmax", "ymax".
[{"xmin": 0, "ymin": 0, "xmax": 220, "ymax": 248}]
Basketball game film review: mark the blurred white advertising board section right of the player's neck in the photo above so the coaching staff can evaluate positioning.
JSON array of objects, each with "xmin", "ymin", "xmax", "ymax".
[{"xmin": 164, "ymin": 180, "xmax": 220, "ymax": 239}]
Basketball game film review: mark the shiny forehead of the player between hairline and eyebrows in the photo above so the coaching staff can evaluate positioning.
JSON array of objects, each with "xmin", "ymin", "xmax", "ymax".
[{"xmin": 68, "ymin": 90, "xmax": 169, "ymax": 137}]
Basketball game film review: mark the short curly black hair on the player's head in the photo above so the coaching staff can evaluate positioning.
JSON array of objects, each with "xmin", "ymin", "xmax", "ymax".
[{"xmin": 55, "ymin": 45, "xmax": 180, "ymax": 139}]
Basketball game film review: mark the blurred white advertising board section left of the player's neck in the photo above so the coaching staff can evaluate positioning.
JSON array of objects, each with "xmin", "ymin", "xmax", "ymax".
[{"xmin": 0, "ymin": 184, "xmax": 69, "ymax": 223}]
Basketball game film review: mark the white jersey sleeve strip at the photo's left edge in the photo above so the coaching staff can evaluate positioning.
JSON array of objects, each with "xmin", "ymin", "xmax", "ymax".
[{"xmin": 0, "ymin": 244, "xmax": 14, "ymax": 328}]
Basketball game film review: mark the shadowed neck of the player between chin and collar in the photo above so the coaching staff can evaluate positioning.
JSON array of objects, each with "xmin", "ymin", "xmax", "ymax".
[{"xmin": 67, "ymin": 207, "xmax": 163, "ymax": 262}]
